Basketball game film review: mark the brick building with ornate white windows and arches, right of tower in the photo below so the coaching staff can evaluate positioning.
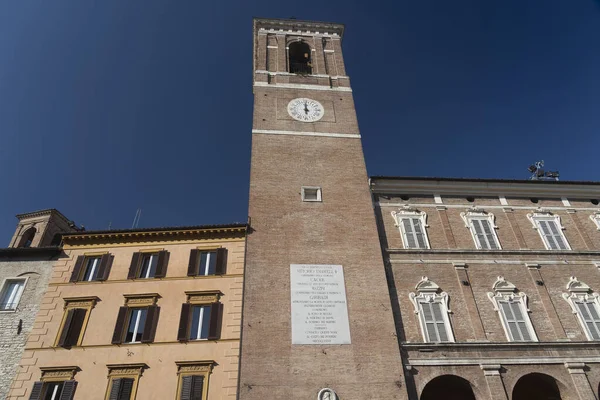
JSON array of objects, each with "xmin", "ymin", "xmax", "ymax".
[{"xmin": 371, "ymin": 177, "xmax": 600, "ymax": 400}]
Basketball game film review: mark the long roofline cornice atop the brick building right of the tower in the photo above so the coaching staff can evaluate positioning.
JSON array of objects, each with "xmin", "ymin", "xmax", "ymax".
[{"xmin": 370, "ymin": 177, "xmax": 600, "ymax": 200}]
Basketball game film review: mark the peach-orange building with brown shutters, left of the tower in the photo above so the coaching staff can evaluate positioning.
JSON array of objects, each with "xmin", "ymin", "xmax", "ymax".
[{"xmin": 8, "ymin": 224, "xmax": 246, "ymax": 400}]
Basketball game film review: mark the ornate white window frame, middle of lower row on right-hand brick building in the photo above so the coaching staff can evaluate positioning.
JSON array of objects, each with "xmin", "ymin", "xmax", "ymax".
[{"xmin": 487, "ymin": 276, "xmax": 539, "ymax": 343}]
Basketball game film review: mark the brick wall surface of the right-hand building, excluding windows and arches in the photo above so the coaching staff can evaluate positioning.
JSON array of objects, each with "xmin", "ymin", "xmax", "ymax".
[{"xmin": 374, "ymin": 191, "xmax": 600, "ymax": 400}]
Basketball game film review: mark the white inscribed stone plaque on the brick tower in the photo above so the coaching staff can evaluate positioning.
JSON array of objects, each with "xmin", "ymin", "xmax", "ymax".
[{"xmin": 290, "ymin": 264, "xmax": 350, "ymax": 345}]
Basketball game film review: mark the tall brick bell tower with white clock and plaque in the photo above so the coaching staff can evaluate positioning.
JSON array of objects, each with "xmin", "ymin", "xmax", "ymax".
[{"xmin": 238, "ymin": 19, "xmax": 407, "ymax": 400}]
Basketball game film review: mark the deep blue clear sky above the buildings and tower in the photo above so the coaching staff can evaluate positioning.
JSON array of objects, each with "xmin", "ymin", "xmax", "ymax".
[{"xmin": 0, "ymin": 0, "xmax": 600, "ymax": 246}]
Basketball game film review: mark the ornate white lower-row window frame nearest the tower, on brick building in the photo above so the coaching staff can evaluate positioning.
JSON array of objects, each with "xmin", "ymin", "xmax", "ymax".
[{"xmin": 408, "ymin": 276, "xmax": 454, "ymax": 343}]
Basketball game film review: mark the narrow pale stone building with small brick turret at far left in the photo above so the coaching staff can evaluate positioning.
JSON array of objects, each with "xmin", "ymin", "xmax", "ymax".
[{"xmin": 0, "ymin": 210, "xmax": 77, "ymax": 399}]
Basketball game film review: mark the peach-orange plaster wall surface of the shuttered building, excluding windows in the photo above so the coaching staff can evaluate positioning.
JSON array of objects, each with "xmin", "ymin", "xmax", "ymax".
[{"xmin": 8, "ymin": 235, "xmax": 244, "ymax": 400}]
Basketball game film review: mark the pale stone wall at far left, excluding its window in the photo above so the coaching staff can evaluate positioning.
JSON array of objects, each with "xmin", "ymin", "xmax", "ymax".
[{"xmin": 0, "ymin": 256, "xmax": 54, "ymax": 399}]
